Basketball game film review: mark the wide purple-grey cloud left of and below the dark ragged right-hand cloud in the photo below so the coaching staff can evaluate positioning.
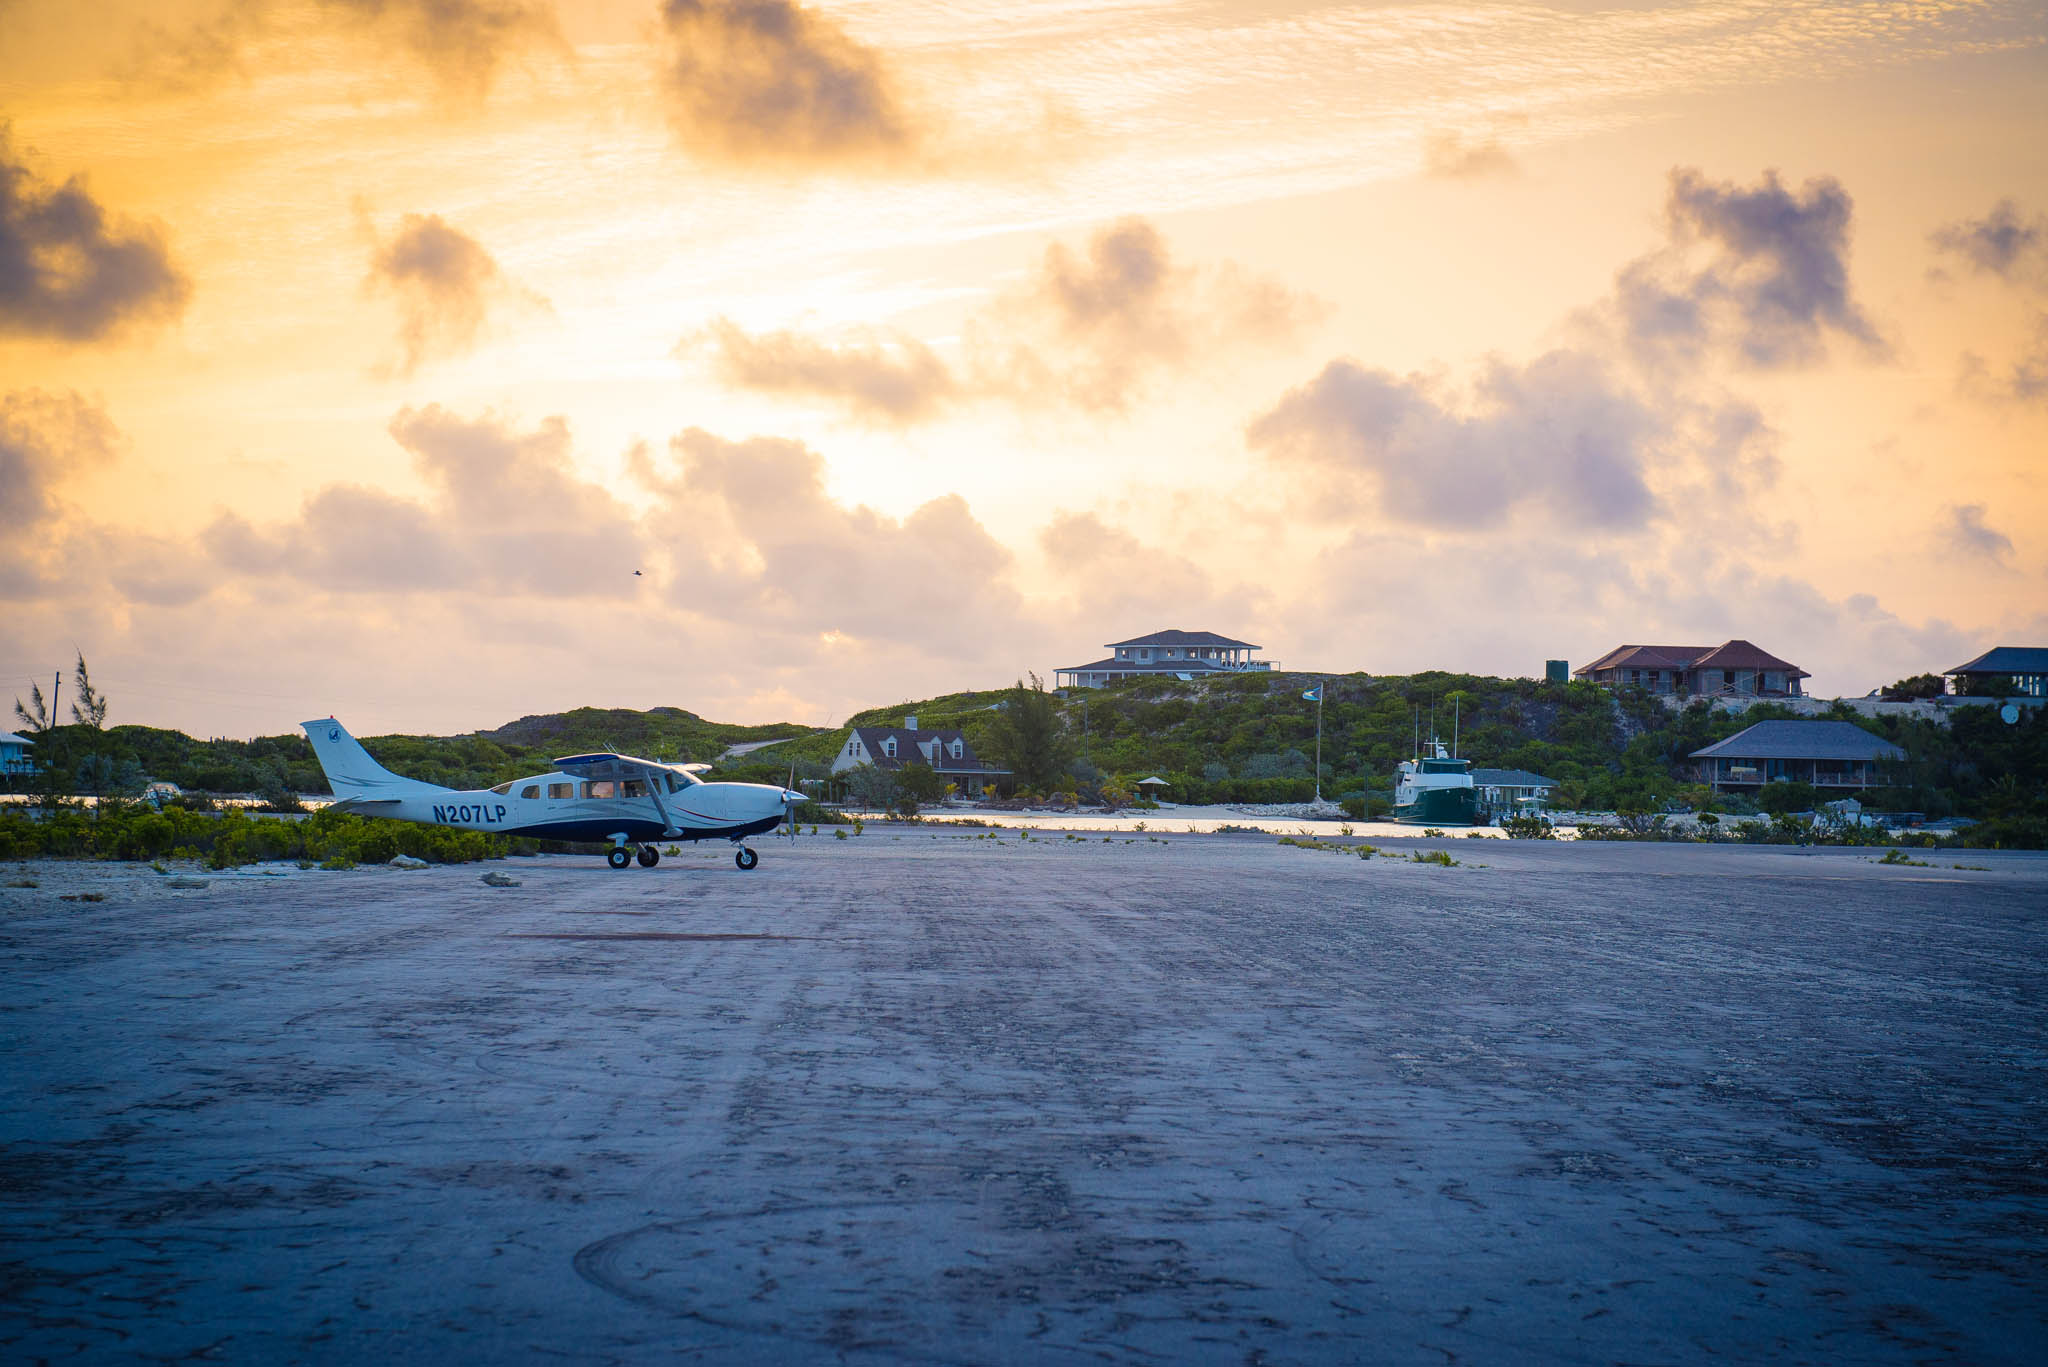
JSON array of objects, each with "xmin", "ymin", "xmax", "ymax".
[{"xmin": 1247, "ymin": 350, "xmax": 1671, "ymax": 531}]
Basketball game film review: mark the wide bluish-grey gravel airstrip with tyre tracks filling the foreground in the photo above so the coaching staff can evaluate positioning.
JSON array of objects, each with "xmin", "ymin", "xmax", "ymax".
[{"xmin": 0, "ymin": 828, "xmax": 2048, "ymax": 1365}]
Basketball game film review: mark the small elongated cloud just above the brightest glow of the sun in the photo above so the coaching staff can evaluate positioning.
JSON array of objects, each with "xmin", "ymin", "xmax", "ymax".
[{"xmin": 678, "ymin": 318, "xmax": 961, "ymax": 422}]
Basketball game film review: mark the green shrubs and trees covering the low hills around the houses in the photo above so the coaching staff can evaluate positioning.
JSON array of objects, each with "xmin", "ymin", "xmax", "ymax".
[{"xmin": 8, "ymin": 660, "xmax": 2048, "ymax": 846}]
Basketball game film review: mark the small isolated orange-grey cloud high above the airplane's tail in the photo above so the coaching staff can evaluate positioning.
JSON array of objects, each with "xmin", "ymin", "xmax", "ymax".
[{"xmin": 365, "ymin": 213, "xmax": 547, "ymax": 375}]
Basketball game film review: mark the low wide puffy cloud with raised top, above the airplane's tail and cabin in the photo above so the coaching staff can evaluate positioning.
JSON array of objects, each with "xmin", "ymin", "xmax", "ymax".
[{"xmin": 203, "ymin": 406, "xmax": 645, "ymax": 598}]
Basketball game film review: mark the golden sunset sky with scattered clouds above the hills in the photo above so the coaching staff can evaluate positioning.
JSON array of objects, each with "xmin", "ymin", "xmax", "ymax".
[{"xmin": 0, "ymin": 0, "xmax": 2048, "ymax": 736}]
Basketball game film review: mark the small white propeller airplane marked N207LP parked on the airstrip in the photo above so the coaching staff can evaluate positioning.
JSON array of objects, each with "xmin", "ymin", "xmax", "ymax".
[{"xmin": 299, "ymin": 717, "xmax": 805, "ymax": 869}]
